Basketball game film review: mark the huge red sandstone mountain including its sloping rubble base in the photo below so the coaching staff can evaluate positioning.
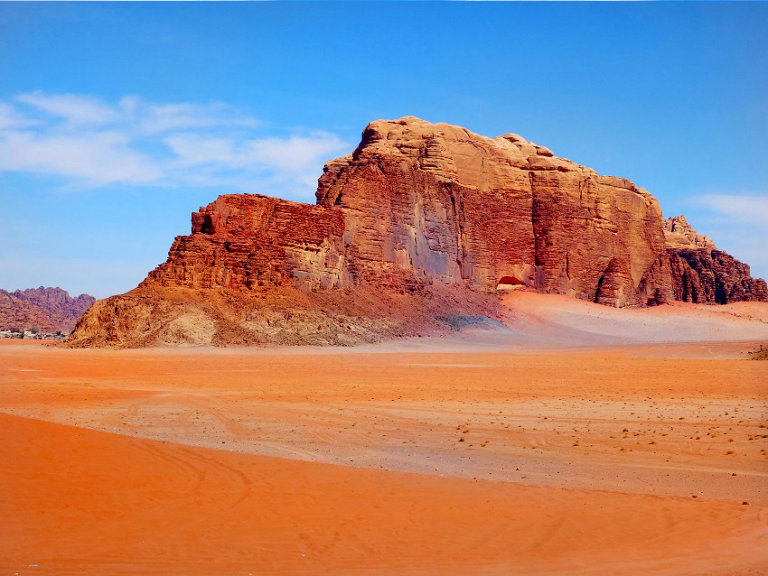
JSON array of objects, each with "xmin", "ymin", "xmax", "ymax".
[{"xmin": 71, "ymin": 117, "xmax": 768, "ymax": 346}]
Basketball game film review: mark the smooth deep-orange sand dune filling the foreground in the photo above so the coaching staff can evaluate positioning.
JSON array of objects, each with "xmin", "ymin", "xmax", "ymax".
[{"xmin": 0, "ymin": 416, "xmax": 768, "ymax": 575}]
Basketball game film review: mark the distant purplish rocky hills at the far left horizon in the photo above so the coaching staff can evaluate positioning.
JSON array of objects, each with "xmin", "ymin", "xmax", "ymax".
[{"xmin": 0, "ymin": 286, "xmax": 96, "ymax": 332}]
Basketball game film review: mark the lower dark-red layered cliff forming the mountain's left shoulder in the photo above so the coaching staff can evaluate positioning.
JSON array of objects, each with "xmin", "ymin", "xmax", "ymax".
[{"xmin": 142, "ymin": 194, "xmax": 352, "ymax": 290}]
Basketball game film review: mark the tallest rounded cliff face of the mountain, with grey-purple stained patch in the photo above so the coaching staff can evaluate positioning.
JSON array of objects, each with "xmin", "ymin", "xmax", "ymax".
[{"xmin": 317, "ymin": 118, "xmax": 669, "ymax": 306}]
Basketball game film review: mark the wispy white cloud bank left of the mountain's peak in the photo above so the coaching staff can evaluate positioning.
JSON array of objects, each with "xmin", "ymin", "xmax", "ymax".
[{"xmin": 0, "ymin": 92, "xmax": 350, "ymax": 197}]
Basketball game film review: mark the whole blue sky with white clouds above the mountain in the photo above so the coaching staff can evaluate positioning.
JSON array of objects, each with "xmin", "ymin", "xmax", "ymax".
[{"xmin": 0, "ymin": 3, "xmax": 768, "ymax": 297}]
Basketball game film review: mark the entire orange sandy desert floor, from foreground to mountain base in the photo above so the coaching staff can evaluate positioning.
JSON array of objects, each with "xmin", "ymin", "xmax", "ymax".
[{"xmin": 0, "ymin": 293, "xmax": 768, "ymax": 575}]
